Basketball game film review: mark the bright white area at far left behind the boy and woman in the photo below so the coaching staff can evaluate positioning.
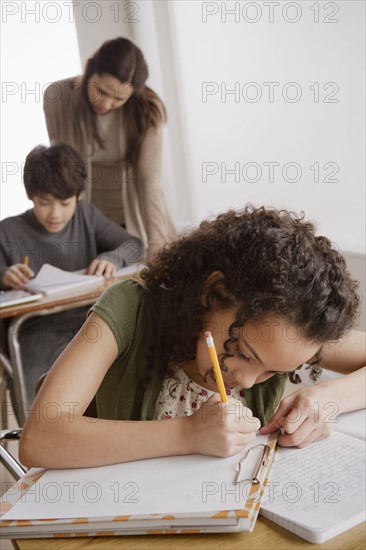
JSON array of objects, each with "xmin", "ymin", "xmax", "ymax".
[{"xmin": 0, "ymin": 0, "xmax": 80, "ymax": 219}]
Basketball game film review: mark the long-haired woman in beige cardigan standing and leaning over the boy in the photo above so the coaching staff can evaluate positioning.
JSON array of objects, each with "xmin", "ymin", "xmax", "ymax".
[{"xmin": 44, "ymin": 38, "xmax": 175, "ymax": 254}]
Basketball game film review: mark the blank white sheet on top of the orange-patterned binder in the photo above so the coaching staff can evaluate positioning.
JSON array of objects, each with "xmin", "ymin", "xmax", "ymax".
[{"xmin": 2, "ymin": 436, "xmax": 268, "ymax": 520}]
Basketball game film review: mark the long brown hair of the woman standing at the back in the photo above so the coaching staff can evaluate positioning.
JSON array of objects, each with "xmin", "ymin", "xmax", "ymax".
[{"xmin": 80, "ymin": 38, "xmax": 166, "ymax": 165}]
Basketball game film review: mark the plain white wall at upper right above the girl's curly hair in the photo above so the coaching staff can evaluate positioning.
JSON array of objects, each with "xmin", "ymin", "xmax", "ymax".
[{"xmin": 166, "ymin": 1, "xmax": 365, "ymax": 252}]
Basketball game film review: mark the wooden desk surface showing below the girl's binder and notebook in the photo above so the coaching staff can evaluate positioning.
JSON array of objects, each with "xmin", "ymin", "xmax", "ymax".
[{"xmin": 14, "ymin": 517, "xmax": 366, "ymax": 550}]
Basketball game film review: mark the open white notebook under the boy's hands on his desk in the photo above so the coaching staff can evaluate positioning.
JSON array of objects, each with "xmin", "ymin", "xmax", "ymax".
[{"xmin": 27, "ymin": 264, "xmax": 142, "ymax": 296}]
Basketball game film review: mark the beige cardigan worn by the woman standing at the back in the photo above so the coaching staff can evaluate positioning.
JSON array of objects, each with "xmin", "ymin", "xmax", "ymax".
[{"xmin": 43, "ymin": 77, "xmax": 175, "ymax": 249}]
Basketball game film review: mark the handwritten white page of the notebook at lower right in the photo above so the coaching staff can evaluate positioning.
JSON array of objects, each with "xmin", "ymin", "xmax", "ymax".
[{"xmin": 262, "ymin": 432, "xmax": 366, "ymax": 528}]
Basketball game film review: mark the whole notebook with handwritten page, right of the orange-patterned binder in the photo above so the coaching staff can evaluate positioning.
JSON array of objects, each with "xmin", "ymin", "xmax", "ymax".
[{"xmin": 260, "ymin": 403, "xmax": 366, "ymax": 544}]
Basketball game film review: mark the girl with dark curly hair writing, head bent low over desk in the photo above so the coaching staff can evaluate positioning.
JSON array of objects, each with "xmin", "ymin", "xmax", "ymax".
[{"xmin": 20, "ymin": 206, "xmax": 366, "ymax": 468}]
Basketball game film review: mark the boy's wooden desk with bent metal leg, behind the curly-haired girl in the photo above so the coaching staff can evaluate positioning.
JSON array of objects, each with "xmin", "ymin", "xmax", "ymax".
[{"xmin": 0, "ymin": 274, "xmax": 131, "ymax": 426}]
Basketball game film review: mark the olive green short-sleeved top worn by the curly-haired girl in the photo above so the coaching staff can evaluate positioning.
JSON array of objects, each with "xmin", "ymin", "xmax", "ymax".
[{"xmin": 91, "ymin": 280, "xmax": 287, "ymax": 425}]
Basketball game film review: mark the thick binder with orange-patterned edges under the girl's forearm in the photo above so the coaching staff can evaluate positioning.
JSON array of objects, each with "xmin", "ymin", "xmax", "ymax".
[{"xmin": 0, "ymin": 435, "xmax": 276, "ymax": 538}]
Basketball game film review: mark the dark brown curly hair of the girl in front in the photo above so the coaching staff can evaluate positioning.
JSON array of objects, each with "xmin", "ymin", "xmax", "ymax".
[{"xmin": 141, "ymin": 205, "xmax": 360, "ymax": 383}]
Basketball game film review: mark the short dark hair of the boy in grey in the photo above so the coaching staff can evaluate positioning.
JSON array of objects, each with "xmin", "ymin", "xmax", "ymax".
[{"xmin": 24, "ymin": 143, "xmax": 86, "ymax": 199}]
